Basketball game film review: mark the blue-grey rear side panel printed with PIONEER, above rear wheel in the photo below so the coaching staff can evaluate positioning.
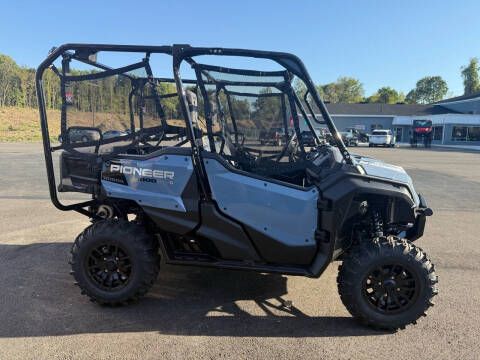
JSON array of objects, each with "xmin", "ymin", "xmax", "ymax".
[{"xmin": 102, "ymin": 150, "xmax": 200, "ymax": 234}]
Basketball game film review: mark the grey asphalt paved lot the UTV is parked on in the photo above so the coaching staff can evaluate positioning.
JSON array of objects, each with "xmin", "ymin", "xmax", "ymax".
[{"xmin": 0, "ymin": 144, "xmax": 480, "ymax": 359}]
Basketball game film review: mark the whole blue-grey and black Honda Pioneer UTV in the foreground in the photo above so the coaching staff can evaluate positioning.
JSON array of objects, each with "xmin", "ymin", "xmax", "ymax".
[{"xmin": 36, "ymin": 44, "xmax": 437, "ymax": 329}]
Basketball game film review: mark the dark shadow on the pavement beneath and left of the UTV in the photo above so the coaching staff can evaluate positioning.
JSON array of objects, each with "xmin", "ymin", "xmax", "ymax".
[{"xmin": 0, "ymin": 243, "xmax": 382, "ymax": 337}]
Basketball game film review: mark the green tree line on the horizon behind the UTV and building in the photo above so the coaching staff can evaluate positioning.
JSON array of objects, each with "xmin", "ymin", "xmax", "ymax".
[{"xmin": 0, "ymin": 54, "xmax": 480, "ymax": 109}]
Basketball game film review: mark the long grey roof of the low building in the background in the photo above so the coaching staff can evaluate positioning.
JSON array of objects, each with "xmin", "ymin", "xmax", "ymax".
[{"xmin": 325, "ymin": 103, "xmax": 456, "ymax": 116}]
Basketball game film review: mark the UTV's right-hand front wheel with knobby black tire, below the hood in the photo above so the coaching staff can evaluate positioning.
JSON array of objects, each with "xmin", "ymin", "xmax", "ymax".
[{"xmin": 337, "ymin": 237, "xmax": 438, "ymax": 330}]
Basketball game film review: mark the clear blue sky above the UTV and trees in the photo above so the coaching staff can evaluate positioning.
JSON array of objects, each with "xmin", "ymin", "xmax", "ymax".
[{"xmin": 0, "ymin": 0, "xmax": 480, "ymax": 96}]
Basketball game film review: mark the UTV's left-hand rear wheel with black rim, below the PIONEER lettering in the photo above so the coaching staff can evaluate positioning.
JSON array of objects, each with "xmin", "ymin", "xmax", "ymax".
[{"xmin": 71, "ymin": 219, "xmax": 160, "ymax": 305}]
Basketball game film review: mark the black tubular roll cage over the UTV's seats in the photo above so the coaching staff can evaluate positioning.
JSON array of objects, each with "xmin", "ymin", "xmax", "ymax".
[{"xmin": 36, "ymin": 44, "xmax": 352, "ymax": 216}]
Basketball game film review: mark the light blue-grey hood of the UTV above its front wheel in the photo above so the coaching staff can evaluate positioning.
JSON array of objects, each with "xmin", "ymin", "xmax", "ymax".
[{"xmin": 352, "ymin": 155, "xmax": 420, "ymax": 205}]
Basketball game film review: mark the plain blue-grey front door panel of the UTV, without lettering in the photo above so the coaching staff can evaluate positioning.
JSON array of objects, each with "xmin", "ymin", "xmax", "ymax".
[{"xmin": 204, "ymin": 158, "xmax": 318, "ymax": 264}]
